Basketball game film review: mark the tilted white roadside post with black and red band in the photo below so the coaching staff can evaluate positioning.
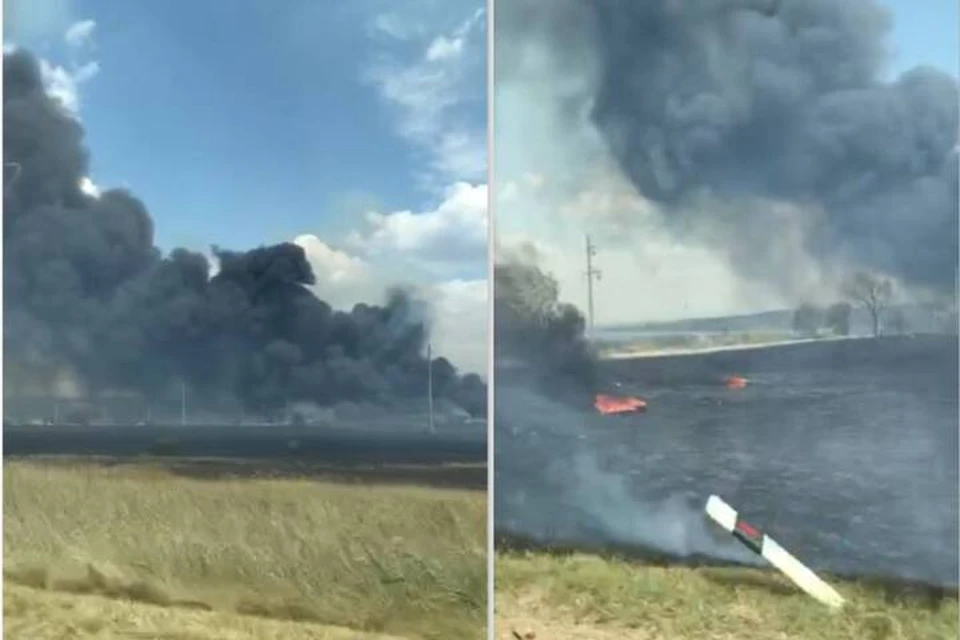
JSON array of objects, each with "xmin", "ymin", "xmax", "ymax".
[{"xmin": 706, "ymin": 496, "xmax": 844, "ymax": 609}]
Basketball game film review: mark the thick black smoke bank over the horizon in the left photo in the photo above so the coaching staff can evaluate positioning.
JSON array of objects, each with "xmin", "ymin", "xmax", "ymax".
[{"xmin": 3, "ymin": 51, "xmax": 486, "ymax": 415}]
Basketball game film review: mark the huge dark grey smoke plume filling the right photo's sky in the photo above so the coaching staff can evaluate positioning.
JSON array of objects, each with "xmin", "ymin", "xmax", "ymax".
[{"xmin": 496, "ymin": 0, "xmax": 958, "ymax": 291}]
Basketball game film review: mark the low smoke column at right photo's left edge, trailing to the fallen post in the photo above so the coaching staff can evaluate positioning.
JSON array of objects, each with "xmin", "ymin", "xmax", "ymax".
[{"xmin": 494, "ymin": 255, "xmax": 754, "ymax": 563}]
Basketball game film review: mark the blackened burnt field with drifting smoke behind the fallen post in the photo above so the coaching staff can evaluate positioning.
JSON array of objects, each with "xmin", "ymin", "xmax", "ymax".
[{"xmin": 495, "ymin": 336, "xmax": 960, "ymax": 585}]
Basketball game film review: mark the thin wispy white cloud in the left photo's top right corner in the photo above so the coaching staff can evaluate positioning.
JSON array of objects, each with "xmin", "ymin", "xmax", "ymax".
[{"xmin": 367, "ymin": 7, "xmax": 486, "ymax": 187}]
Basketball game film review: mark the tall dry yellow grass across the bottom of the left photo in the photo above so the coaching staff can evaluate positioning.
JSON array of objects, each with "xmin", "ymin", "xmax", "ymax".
[{"xmin": 3, "ymin": 461, "xmax": 486, "ymax": 640}]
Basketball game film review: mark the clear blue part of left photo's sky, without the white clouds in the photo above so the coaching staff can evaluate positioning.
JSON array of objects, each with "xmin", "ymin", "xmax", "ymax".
[{"xmin": 4, "ymin": 0, "xmax": 486, "ymax": 264}]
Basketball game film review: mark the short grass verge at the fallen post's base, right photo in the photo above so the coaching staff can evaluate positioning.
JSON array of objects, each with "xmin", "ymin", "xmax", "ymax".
[{"xmin": 496, "ymin": 553, "xmax": 960, "ymax": 640}]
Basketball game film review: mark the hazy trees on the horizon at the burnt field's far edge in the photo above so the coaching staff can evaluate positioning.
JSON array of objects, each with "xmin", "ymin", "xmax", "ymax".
[{"xmin": 793, "ymin": 273, "xmax": 907, "ymax": 336}]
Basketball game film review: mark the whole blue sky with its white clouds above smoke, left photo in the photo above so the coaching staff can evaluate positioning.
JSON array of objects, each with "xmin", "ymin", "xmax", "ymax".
[{"xmin": 4, "ymin": 0, "xmax": 487, "ymax": 376}]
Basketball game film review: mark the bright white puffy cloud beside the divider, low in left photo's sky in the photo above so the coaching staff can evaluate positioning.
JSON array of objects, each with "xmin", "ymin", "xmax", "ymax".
[{"xmin": 350, "ymin": 182, "xmax": 487, "ymax": 267}]
